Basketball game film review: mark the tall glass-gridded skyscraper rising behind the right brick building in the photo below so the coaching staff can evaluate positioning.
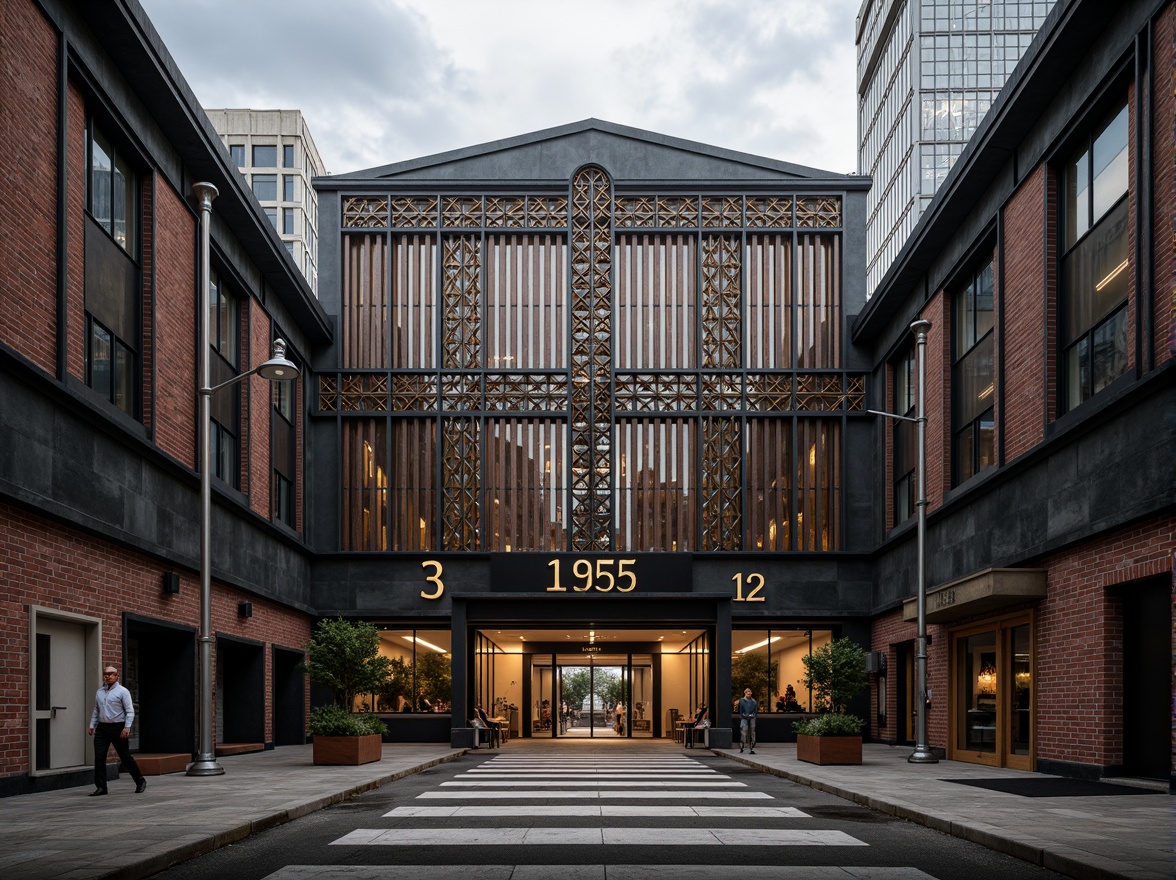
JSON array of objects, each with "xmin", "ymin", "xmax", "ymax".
[{"xmin": 855, "ymin": 0, "xmax": 1054, "ymax": 295}]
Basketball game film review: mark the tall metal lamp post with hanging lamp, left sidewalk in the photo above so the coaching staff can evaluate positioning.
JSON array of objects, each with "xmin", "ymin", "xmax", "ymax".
[{"xmin": 187, "ymin": 184, "xmax": 299, "ymax": 776}]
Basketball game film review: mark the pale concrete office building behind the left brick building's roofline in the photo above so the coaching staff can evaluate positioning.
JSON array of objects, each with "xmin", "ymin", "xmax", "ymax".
[{"xmin": 205, "ymin": 109, "xmax": 326, "ymax": 295}]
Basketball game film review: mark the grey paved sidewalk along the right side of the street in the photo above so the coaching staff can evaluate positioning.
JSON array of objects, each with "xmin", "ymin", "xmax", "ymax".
[{"xmin": 713, "ymin": 744, "xmax": 1176, "ymax": 880}]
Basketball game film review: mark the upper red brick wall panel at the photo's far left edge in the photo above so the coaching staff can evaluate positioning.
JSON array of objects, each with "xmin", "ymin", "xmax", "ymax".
[{"xmin": 0, "ymin": 2, "xmax": 58, "ymax": 373}]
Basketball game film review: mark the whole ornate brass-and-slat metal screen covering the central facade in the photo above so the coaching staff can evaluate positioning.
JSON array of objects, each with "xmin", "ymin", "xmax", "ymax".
[{"xmin": 318, "ymin": 181, "xmax": 866, "ymax": 552}]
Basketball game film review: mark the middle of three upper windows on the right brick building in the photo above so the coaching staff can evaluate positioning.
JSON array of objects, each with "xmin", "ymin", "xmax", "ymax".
[{"xmin": 951, "ymin": 260, "xmax": 996, "ymax": 486}]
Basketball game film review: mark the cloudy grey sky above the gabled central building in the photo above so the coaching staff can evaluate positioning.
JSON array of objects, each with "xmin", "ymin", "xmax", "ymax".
[{"xmin": 141, "ymin": 0, "xmax": 861, "ymax": 173}]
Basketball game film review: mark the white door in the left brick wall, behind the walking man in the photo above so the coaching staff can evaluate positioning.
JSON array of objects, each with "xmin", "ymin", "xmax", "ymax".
[{"xmin": 33, "ymin": 616, "xmax": 94, "ymax": 769}]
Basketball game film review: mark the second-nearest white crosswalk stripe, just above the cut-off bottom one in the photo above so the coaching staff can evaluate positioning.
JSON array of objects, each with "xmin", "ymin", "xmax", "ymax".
[{"xmin": 332, "ymin": 827, "xmax": 867, "ymax": 847}]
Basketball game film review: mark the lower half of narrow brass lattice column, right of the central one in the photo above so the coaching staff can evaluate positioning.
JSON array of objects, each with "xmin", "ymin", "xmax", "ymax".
[{"xmin": 702, "ymin": 419, "xmax": 743, "ymax": 551}]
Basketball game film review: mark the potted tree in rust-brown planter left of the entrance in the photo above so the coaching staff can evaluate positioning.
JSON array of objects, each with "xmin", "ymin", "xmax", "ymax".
[{"xmin": 305, "ymin": 618, "xmax": 390, "ymax": 764}]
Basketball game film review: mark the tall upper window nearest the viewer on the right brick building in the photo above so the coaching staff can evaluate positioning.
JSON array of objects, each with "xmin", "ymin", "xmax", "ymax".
[{"xmin": 1058, "ymin": 104, "xmax": 1130, "ymax": 411}]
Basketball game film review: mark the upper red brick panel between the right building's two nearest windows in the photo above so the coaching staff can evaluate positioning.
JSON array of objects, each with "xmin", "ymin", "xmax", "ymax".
[{"xmin": 997, "ymin": 167, "xmax": 1045, "ymax": 461}]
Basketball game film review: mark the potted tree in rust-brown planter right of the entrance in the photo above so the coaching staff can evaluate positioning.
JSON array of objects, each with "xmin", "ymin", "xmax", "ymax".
[{"xmin": 793, "ymin": 639, "xmax": 870, "ymax": 764}]
